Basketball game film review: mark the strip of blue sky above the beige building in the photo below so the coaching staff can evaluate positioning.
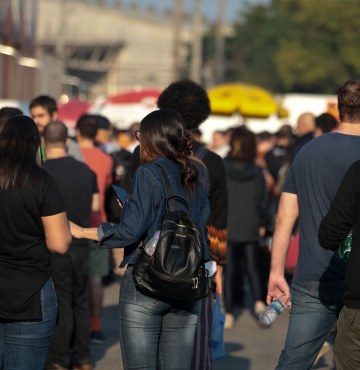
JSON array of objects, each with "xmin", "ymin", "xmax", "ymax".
[{"xmin": 114, "ymin": 0, "xmax": 268, "ymax": 22}]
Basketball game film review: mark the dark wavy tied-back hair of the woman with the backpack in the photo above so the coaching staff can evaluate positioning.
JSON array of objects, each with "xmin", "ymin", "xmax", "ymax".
[{"xmin": 140, "ymin": 109, "xmax": 198, "ymax": 192}]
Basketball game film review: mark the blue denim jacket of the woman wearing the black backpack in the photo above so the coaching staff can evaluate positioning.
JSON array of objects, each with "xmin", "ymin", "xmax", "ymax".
[{"xmin": 98, "ymin": 157, "xmax": 210, "ymax": 266}]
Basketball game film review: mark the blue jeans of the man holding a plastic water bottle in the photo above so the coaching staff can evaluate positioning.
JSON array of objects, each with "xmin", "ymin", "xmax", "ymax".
[{"xmin": 276, "ymin": 281, "xmax": 345, "ymax": 370}]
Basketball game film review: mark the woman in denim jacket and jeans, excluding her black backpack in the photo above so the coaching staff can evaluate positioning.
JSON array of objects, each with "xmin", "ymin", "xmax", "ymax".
[{"xmin": 71, "ymin": 109, "xmax": 210, "ymax": 370}]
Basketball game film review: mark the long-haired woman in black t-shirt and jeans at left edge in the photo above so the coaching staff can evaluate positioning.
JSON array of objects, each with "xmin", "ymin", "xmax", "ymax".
[{"xmin": 0, "ymin": 115, "xmax": 71, "ymax": 370}]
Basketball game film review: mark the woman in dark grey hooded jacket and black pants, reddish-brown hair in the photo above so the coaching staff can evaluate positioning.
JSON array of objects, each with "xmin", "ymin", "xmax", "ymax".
[{"xmin": 224, "ymin": 127, "xmax": 267, "ymax": 328}]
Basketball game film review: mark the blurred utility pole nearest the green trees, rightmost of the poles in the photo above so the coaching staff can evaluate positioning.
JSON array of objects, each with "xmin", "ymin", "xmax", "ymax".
[{"xmin": 214, "ymin": 0, "xmax": 226, "ymax": 84}]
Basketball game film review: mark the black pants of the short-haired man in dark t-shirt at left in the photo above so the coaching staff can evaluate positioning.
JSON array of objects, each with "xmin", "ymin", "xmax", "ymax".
[{"xmin": 47, "ymin": 240, "xmax": 91, "ymax": 367}]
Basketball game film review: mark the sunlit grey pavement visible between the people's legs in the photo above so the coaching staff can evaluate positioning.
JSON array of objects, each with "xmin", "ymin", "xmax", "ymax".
[{"xmin": 92, "ymin": 283, "xmax": 334, "ymax": 370}]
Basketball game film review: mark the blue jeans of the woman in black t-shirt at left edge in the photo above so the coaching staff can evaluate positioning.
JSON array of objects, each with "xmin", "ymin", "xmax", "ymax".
[{"xmin": 0, "ymin": 279, "xmax": 57, "ymax": 370}]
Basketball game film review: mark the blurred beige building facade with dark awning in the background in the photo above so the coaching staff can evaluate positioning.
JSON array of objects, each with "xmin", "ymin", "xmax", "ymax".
[{"xmin": 36, "ymin": 0, "xmax": 191, "ymax": 99}]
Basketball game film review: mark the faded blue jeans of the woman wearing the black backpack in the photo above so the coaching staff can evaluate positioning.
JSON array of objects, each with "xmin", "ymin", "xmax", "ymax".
[{"xmin": 119, "ymin": 266, "xmax": 200, "ymax": 370}]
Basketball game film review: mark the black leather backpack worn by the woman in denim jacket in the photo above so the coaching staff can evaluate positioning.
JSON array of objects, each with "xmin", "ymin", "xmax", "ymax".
[{"xmin": 133, "ymin": 165, "xmax": 216, "ymax": 301}]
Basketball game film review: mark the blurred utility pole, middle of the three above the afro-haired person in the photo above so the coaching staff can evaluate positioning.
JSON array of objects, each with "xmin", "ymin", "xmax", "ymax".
[{"xmin": 191, "ymin": 0, "xmax": 202, "ymax": 83}]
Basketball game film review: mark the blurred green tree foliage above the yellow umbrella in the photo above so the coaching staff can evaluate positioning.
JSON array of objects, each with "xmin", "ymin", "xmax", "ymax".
[{"xmin": 218, "ymin": 0, "xmax": 360, "ymax": 94}]
